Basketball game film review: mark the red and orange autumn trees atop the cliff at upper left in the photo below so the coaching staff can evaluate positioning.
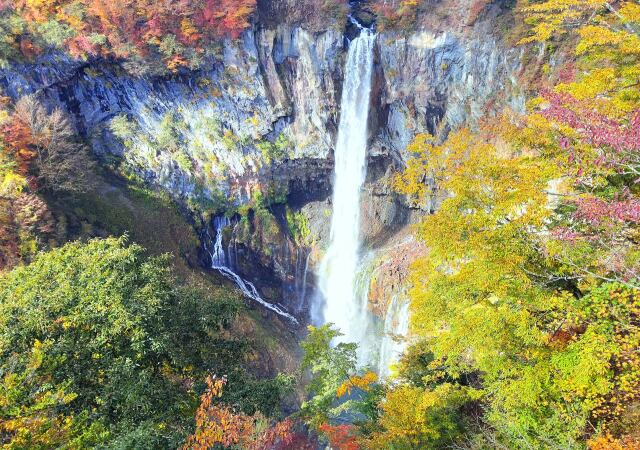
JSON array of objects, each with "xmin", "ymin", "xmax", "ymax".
[{"xmin": 0, "ymin": 0, "xmax": 256, "ymax": 69}]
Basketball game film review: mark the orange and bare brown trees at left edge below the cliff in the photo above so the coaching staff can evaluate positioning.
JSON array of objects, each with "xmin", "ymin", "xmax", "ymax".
[{"xmin": 0, "ymin": 97, "xmax": 93, "ymax": 269}]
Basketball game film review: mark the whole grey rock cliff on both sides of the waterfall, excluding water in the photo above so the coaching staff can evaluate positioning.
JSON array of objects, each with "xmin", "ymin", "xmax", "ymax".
[{"xmin": 0, "ymin": 2, "xmax": 523, "ymax": 324}]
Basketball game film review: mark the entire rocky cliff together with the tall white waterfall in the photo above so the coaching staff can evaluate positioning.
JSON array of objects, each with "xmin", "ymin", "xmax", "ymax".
[{"xmin": 0, "ymin": 0, "xmax": 521, "ymax": 371}]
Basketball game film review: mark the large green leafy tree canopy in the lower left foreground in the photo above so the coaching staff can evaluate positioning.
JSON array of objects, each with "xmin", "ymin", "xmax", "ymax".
[{"xmin": 0, "ymin": 238, "xmax": 284, "ymax": 449}]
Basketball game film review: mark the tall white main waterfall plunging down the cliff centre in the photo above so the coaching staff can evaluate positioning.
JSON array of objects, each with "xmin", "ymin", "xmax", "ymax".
[{"xmin": 319, "ymin": 29, "xmax": 375, "ymax": 362}]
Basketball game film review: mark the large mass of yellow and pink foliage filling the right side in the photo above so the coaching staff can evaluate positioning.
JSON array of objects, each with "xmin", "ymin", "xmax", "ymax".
[{"xmin": 372, "ymin": 0, "xmax": 640, "ymax": 449}]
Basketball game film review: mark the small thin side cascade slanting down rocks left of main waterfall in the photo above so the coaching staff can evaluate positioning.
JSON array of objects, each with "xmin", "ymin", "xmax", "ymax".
[{"xmin": 207, "ymin": 216, "xmax": 298, "ymax": 324}]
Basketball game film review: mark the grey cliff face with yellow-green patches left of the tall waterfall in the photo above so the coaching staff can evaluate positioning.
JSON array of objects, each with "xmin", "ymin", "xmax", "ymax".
[{"xmin": 0, "ymin": 26, "xmax": 342, "ymax": 201}]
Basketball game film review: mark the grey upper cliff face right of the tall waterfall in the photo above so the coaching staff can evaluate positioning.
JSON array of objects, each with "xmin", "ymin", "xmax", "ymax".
[{"xmin": 374, "ymin": 27, "xmax": 524, "ymax": 160}]
